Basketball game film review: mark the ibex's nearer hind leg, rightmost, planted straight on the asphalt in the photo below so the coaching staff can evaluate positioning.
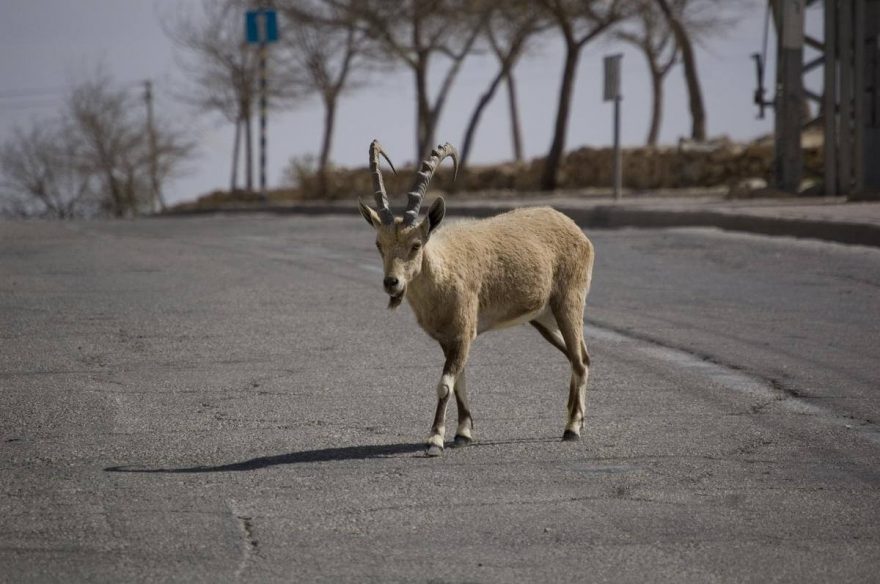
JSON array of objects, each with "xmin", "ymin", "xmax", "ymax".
[{"xmin": 553, "ymin": 298, "xmax": 590, "ymax": 441}]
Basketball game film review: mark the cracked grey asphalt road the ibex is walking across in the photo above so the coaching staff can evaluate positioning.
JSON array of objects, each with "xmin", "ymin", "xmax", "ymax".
[{"xmin": 0, "ymin": 216, "xmax": 880, "ymax": 584}]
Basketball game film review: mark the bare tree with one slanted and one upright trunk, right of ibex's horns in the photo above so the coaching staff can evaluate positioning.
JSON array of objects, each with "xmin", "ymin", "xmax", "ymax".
[{"xmin": 460, "ymin": 1, "xmax": 549, "ymax": 169}]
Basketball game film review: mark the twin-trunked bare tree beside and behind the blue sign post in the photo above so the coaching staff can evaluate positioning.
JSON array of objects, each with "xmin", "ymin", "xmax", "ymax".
[{"xmin": 163, "ymin": 0, "xmax": 299, "ymax": 191}]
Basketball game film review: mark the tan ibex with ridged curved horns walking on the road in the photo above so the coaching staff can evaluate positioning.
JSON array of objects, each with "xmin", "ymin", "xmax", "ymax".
[{"xmin": 359, "ymin": 140, "xmax": 594, "ymax": 456}]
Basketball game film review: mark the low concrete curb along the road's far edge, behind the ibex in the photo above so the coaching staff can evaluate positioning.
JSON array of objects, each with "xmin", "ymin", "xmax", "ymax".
[{"xmin": 163, "ymin": 203, "xmax": 880, "ymax": 247}]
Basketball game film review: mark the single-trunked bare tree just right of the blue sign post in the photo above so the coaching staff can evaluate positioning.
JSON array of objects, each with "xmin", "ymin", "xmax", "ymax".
[{"xmin": 279, "ymin": 0, "xmax": 373, "ymax": 196}]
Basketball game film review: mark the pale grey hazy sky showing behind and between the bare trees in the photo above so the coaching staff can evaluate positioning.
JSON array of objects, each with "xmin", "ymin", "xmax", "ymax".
[{"xmin": 0, "ymin": 0, "xmax": 821, "ymax": 201}]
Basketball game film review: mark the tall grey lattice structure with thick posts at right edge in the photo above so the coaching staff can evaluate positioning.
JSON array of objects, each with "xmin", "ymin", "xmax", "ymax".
[{"xmin": 770, "ymin": 0, "xmax": 880, "ymax": 199}]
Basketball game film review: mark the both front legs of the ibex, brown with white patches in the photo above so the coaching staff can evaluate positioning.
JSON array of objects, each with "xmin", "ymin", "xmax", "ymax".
[{"xmin": 427, "ymin": 338, "xmax": 471, "ymax": 456}]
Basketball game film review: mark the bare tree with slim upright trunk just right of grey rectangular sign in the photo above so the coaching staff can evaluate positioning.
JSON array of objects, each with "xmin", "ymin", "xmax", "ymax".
[{"xmin": 614, "ymin": 0, "xmax": 687, "ymax": 146}]
